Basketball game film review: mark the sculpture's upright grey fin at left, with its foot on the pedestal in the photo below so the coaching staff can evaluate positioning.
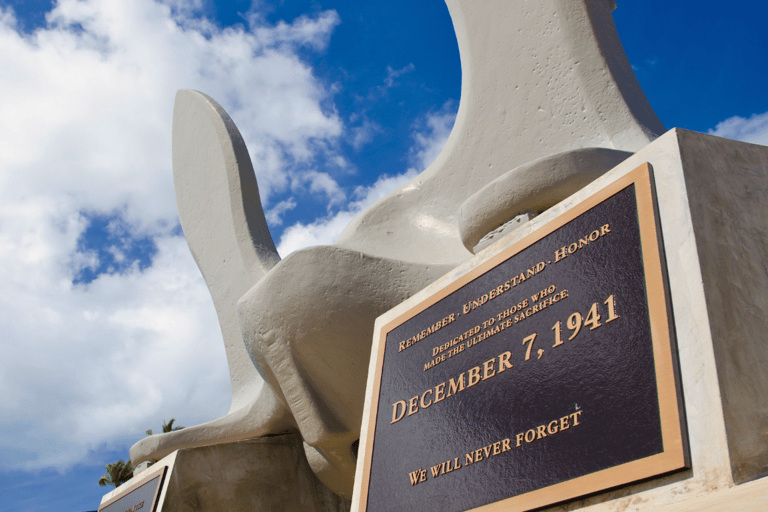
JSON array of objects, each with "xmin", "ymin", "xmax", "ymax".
[{"xmin": 131, "ymin": 91, "xmax": 296, "ymax": 472}]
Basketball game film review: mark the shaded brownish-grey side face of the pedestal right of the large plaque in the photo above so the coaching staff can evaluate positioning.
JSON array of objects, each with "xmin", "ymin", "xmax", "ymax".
[{"xmin": 678, "ymin": 130, "xmax": 768, "ymax": 483}]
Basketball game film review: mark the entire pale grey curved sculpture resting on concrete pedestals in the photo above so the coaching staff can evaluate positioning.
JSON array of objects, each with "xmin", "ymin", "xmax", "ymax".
[{"xmin": 131, "ymin": 0, "xmax": 664, "ymax": 497}]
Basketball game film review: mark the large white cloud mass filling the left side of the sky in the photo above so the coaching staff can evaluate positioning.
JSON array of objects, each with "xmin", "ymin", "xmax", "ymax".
[{"xmin": 0, "ymin": 0, "xmax": 344, "ymax": 469}]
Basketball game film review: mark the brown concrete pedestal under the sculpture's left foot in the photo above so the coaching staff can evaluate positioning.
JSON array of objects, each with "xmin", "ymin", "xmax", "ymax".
[{"xmin": 100, "ymin": 434, "xmax": 349, "ymax": 512}]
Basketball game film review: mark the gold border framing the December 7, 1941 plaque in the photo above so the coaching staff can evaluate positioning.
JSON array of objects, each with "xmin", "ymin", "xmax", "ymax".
[{"xmin": 352, "ymin": 162, "xmax": 689, "ymax": 512}]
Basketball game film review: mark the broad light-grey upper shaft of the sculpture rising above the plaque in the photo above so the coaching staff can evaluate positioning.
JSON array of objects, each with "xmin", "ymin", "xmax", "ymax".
[{"xmin": 336, "ymin": 0, "xmax": 666, "ymax": 265}]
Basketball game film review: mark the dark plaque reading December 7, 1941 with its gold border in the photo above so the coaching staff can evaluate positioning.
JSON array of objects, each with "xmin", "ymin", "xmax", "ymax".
[{"xmin": 355, "ymin": 164, "xmax": 688, "ymax": 512}]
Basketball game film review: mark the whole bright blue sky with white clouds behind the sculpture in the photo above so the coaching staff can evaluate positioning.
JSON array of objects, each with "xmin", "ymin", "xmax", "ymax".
[{"xmin": 0, "ymin": 0, "xmax": 768, "ymax": 512}]
